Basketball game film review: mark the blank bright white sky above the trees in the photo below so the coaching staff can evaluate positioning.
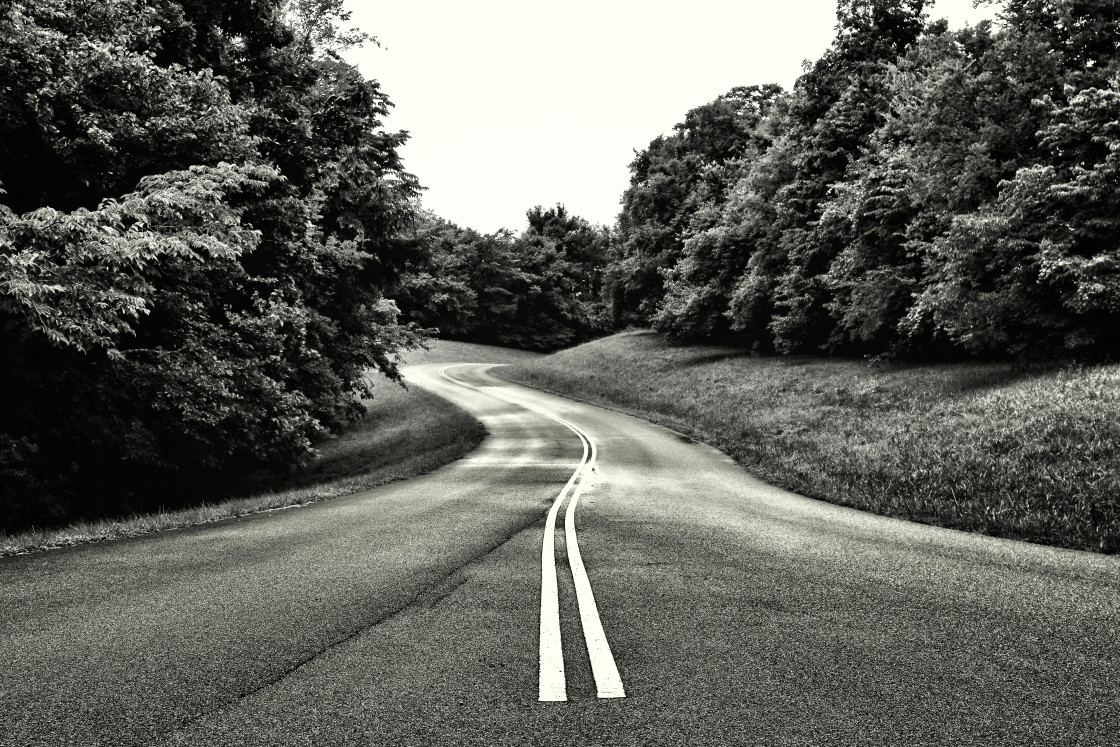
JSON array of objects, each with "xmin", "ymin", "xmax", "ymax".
[{"xmin": 347, "ymin": 0, "xmax": 995, "ymax": 232}]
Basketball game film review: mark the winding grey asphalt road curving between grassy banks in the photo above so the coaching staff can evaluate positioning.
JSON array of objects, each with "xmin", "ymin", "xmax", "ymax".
[{"xmin": 0, "ymin": 365, "xmax": 1120, "ymax": 747}]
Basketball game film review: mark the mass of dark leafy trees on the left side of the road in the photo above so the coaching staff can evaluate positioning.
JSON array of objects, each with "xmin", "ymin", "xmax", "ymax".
[{"xmin": 0, "ymin": 0, "xmax": 419, "ymax": 527}]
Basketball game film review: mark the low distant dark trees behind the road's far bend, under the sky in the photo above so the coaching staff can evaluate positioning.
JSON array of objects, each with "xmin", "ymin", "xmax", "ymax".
[{"xmin": 393, "ymin": 205, "xmax": 609, "ymax": 351}]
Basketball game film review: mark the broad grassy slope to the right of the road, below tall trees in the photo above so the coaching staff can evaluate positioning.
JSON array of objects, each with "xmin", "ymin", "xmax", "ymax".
[{"xmin": 501, "ymin": 333, "xmax": 1120, "ymax": 552}]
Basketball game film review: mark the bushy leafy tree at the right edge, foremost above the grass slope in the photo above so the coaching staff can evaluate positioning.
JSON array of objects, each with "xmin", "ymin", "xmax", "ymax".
[{"xmin": 908, "ymin": 80, "xmax": 1120, "ymax": 356}]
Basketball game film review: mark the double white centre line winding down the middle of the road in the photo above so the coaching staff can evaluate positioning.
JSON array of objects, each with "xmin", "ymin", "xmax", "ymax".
[{"xmin": 439, "ymin": 364, "xmax": 626, "ymax": 701}]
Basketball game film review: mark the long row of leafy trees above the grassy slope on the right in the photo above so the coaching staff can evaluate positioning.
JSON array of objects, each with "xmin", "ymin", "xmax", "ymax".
[{"xmin": 605, "ymin": 0, "xmax": 1120, "ymax": 357}]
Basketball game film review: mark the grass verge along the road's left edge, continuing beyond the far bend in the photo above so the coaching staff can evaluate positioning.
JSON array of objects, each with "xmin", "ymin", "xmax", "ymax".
[{"xmin": 0, "ymin": 340, "xmax": 539, "ymax": 557}]
